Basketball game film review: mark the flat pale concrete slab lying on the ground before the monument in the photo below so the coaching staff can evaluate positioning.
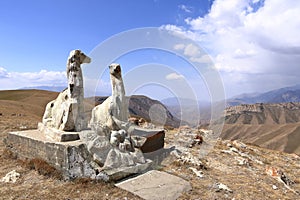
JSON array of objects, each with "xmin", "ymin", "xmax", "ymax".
[{"xmin": 116, "ymin": 170, "xmax": 192, "ymax": 200}]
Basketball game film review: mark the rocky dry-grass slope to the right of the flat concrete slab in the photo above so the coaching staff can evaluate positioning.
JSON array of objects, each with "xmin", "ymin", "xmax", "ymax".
[{"xmin": 163, "ymin": 129, "xmax": 300, "ymax": 199}]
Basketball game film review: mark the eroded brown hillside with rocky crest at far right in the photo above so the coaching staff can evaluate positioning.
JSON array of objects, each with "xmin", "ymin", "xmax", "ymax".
[{"xmin": 221, "ymin": 103, "xmax": 300, "ymax": 154}]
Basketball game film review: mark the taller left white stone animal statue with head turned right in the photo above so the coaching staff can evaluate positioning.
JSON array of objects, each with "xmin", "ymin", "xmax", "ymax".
[{"xmin": 43, "ymin": 50, "xmax": 91, "ymax": 131}]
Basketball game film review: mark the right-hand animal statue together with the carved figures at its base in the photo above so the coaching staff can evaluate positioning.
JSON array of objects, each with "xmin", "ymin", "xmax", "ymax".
[{"xmin": 87, "ymin": 63, "xmax": 146, "ymax": 169}]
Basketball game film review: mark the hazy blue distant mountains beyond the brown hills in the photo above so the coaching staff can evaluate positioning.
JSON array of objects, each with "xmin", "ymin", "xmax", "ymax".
[{"xmin": 161, "ymin": 84, "xmax": 300, "ymax": 126}]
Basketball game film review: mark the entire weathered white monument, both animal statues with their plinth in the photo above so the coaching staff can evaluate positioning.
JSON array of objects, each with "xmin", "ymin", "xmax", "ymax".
[{"xmin": 5, "ymin": 50, "xmax": 165, "ymax": 180}]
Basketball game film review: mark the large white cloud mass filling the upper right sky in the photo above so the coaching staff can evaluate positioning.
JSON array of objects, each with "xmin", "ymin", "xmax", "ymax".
[{"xmin": 164, "ymin": 0, "xmax": 300, "ymax": 96}]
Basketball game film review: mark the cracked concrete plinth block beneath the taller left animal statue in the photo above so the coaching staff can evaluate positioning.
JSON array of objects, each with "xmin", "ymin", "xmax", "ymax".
[{"xmin": 5, "ymin": 130, "xmax": 96, "ymax": 179}]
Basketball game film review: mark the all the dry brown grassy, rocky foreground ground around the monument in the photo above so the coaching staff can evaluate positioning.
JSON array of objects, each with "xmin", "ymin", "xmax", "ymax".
[{"xmin": 0, "ymin": 121, "xmax": 300, "ymax": 199}]
